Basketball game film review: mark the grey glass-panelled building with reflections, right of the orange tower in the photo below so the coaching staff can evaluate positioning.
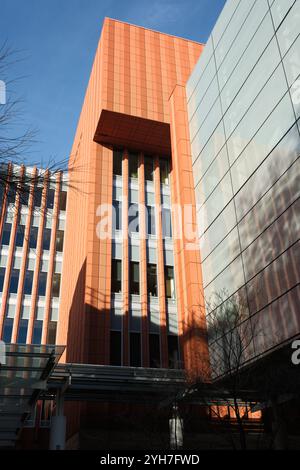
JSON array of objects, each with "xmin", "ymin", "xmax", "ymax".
[{"xmin": 187, "ymin": 0, "xmax": 300, "ymax": 370}]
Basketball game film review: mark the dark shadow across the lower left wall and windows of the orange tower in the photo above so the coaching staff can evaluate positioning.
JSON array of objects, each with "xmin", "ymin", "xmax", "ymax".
[{"xmin": 66, "ymin": 261, "xmax": 188, "ymax": 369}]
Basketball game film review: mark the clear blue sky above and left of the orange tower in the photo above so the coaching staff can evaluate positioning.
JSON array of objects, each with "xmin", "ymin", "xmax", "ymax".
[{"xmin": 0, "ymin": 0, "xmax": 225, "ymax": 169}]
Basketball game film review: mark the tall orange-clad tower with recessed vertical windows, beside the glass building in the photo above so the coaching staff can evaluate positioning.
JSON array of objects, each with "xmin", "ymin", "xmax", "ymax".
[{"xmin": 57, "ymin": 18, "xmax": 207, "ymax": 369}]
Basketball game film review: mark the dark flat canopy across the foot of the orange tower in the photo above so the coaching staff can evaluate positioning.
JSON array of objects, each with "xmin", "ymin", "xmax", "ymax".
[{"xmin": 43, "ymin": 364, "xmax": 186, "ymax": 403}]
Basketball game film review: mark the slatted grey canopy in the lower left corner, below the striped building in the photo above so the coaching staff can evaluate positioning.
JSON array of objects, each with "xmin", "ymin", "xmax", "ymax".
[{"xmin": 0, "ymin": 344, "xmax": 64, "ymax": 447}]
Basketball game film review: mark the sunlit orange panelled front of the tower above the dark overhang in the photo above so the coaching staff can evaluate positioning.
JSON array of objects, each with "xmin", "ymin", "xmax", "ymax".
[{"xmin": 102, "ymin": 19, "xmax": 203, "ymax": 122}]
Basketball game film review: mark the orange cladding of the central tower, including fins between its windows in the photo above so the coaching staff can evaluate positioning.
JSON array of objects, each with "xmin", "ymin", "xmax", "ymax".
[{"xmin": 57, "ymin": 18, "xmax": 208, "ymax": 370}]
